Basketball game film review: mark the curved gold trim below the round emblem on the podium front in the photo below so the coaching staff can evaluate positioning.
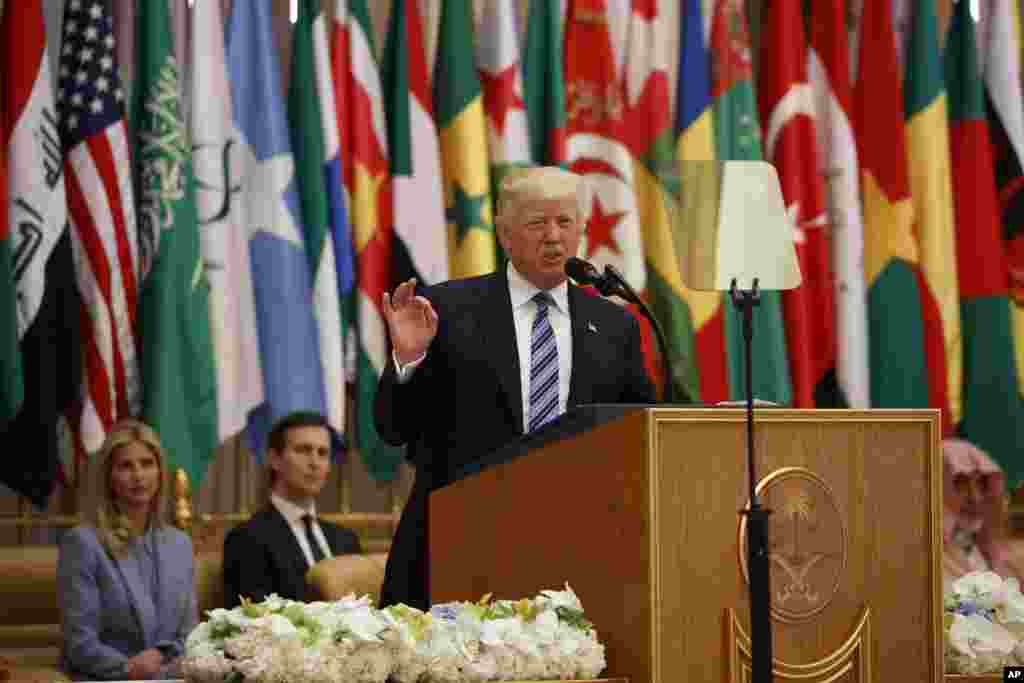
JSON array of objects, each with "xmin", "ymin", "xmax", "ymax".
[{"xmin": 725, "ymin": 606, "xmax": 874, "ymax": 683}]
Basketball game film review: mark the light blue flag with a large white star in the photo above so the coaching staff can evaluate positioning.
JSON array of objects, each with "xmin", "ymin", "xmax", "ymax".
[{"xmin": 225, "ymin": 2, "xmax": 325, "ymax": 458}]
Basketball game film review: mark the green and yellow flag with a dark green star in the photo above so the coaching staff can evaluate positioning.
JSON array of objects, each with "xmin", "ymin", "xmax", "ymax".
[{"xmin": 434, "ymin": 0, "xmax": 496, "ymax": 278}]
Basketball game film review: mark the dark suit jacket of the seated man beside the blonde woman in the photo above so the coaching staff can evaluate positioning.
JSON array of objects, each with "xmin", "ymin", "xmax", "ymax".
[{"xmin": 224, "ymin": 505, "xmax": 361, "ymax": 609}]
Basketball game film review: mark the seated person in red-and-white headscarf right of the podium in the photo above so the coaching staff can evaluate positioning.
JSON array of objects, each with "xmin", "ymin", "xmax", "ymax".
[{"xmin": 942, "ymin": 438, "xmax": 1020, "ymax": 585}]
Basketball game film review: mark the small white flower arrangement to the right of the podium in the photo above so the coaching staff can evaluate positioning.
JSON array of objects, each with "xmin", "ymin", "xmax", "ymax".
[{"xmin": 943, "ymin": 571, "xmax": 1024, "ymax": 676}]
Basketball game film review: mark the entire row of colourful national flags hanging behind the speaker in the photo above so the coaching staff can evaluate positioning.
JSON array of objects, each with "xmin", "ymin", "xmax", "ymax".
[{"xmin": 0, "ymin": 0, "xmax": 1024, "ymax": 504}]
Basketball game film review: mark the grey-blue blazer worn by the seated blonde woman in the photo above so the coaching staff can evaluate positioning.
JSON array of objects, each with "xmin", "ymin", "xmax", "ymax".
[{"xmin": 57, "ymin": 526, "xmax": 197, "ymax": 680}]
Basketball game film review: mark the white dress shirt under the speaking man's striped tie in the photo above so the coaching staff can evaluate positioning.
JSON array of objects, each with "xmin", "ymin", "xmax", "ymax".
[{"xmin": 391, "ymin": 261, "xmax": 572, "ymax": 432}]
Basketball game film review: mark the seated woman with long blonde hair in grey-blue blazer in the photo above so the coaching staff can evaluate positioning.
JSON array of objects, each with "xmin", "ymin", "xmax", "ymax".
[{"xmin": 57, "ymin": 420, "xmax": 197, "ymax": 680}]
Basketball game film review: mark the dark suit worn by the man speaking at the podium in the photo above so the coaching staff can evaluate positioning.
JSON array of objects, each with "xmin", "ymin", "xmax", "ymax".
[{"xmin": 375, "ymin": 270, "xmax": 654, "ymax": 608}]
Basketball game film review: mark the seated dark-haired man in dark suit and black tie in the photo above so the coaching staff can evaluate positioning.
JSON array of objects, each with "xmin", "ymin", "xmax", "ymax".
[{"xmin": 224, "ymin": 413, "xmax": 360, "ymax": 608}]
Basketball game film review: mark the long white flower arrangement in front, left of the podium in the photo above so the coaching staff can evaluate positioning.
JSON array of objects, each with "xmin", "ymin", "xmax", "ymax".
[{"xmin": 181, "ymin": 585, "xmax": 605, "ymax": 683}]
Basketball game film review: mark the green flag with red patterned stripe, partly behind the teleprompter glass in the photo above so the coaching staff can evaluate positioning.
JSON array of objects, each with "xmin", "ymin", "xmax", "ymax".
[{"xmin": 711, "ymin": 2, "xmax": 793, "ymax": 405}]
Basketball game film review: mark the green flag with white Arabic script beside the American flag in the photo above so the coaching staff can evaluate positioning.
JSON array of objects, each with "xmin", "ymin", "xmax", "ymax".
[{"xmin": 132, "ymin": 2, "xmax": 217, "ymax": 487}]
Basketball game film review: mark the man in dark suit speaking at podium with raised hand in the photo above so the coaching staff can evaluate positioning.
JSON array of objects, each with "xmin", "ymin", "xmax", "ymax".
[{"xmin": 375, "ymin": 167, "xmax": 654, "ymax": 609}]
